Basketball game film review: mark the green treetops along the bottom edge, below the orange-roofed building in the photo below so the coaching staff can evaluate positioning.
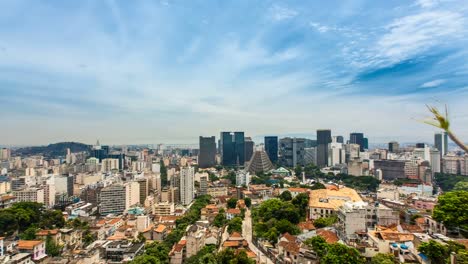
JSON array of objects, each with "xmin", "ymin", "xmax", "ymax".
[{"xmin": 304, "ymin": 236, "xmax": 366, "ymax": 264}]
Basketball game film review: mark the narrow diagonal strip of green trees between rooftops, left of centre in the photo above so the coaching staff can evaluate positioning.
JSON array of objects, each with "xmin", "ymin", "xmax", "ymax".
[{"xmin": 164, "ymin": 195, "xmax": 211, "ymax": 248}]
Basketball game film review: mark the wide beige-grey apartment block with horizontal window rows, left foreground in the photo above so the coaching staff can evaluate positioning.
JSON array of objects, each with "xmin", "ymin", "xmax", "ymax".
[{"xmin": 99, "ymin": 184, "xmax": 127, "ymax": 215}]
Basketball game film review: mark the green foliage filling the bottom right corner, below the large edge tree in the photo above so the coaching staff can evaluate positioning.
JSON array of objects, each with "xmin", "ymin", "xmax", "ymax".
[{"xmin": 418, "ymin": 240, "xmax": 468, "ymax": 264}]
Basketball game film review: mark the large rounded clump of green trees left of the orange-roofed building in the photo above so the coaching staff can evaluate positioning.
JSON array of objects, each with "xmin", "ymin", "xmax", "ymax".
[{"xmin": 252, "ymin": 199, "xmax": 301, "ymax": 243}]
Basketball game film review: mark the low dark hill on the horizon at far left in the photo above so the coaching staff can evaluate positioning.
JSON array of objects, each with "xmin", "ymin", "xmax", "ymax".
[{"xmin": 13, "ymin": 142, "xmax": 91, "ymax": 158}]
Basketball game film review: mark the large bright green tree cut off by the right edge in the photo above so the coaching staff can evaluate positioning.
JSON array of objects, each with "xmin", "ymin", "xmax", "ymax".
[{"xmin": 432, "ymin": 191, "xmax": 468, "ymax": 233}]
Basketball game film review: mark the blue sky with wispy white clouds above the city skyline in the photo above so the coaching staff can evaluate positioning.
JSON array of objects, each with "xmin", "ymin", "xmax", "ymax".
[{"xmin": 0, "ymin": 0, "xmax": 468, "ymax": 145}]
